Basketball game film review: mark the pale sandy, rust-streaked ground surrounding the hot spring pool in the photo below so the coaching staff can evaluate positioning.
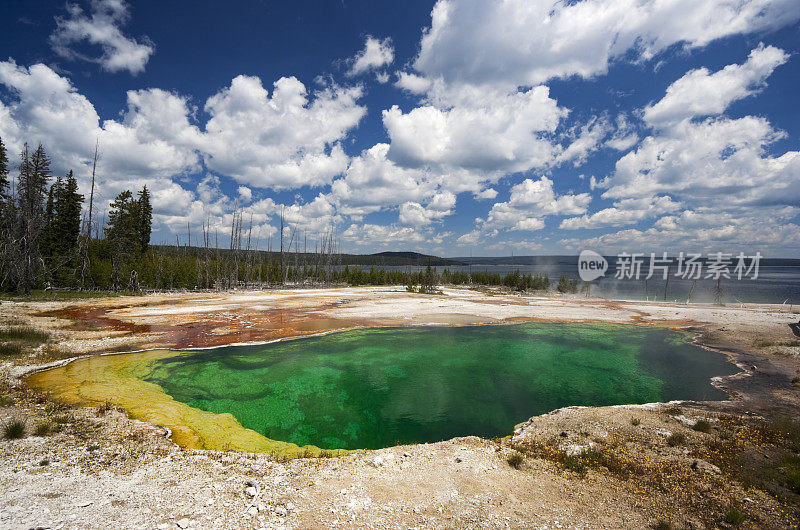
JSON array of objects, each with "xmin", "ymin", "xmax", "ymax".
[{"xmin": 0, "ymin": 287, "xmax": 800, "ymax": 528}]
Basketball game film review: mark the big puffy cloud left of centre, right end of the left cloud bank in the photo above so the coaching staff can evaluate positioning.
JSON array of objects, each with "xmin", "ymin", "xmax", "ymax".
[{"xmin": 203, "ymin": 75, "xmax": 366, "ymax": 188}]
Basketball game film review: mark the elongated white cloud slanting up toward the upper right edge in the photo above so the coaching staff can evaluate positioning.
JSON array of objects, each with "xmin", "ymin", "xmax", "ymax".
[{"xmin": 644, "ymin": 44, "xmax": 789, "ymax": 127}]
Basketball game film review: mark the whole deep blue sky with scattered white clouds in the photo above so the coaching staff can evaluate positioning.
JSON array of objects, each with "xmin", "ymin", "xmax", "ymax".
[{"xmin": 0, "ymin": 0, "xmax": 800, "ymax": 257}]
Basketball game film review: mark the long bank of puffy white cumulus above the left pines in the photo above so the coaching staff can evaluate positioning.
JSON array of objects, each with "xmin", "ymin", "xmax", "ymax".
[{"xmin": 0, "ymin": 61, "xmax": 368, "ymax": 239}]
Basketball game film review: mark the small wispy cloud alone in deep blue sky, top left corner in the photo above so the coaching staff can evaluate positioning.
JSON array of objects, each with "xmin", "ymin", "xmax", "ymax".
[{"xmin": 50, "ymin": 0, "xmax": 155, "ymax": 74}]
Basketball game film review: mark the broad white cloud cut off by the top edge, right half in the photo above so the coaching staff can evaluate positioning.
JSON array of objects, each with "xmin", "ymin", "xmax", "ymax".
[{"xmin": 414, "ymin": 0, "xmax": 800, "ymax": 87}]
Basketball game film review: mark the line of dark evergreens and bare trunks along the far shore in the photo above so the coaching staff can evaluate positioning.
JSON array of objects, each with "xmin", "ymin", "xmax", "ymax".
[{"xmin": 0, "ymin": 138, "xmax": 577, "ymax": 295}]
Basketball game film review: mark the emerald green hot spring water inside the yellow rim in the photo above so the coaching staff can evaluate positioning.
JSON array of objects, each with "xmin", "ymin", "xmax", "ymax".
[{"xmin": 144, "ymin": 323, "xmax": 737, "ymax": 449}]
